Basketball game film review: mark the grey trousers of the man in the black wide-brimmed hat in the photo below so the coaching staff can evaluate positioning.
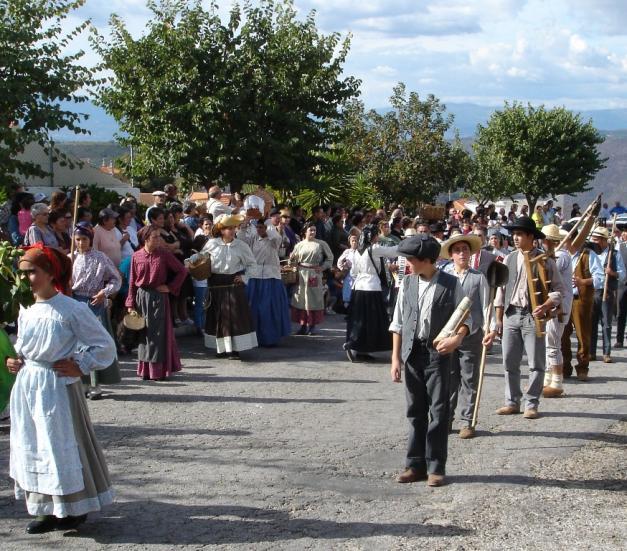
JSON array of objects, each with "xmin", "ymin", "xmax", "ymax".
[{"xmin": 502, "ymin": 306, "xmax": 546, "ymax": 409}]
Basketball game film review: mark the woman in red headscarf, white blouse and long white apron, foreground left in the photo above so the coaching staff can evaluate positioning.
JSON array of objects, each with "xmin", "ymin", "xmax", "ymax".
[{"xmin": 6, "ymin": 243, "xmax": 115, "ymax": 534}]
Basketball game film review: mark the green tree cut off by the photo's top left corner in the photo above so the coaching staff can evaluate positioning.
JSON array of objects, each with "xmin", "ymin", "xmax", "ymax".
[{"xmin": 0, "ymin": 0, "xmax": 98, "ymax": 187}]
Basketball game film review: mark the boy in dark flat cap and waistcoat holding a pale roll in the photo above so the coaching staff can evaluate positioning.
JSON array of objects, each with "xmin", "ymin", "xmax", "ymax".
[{"xmin": 390, "ymin": 235, "xmax": 472, "ymax": 486}]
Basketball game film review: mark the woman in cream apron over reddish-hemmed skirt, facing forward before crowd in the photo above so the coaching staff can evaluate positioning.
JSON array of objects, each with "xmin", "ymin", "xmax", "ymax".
[{"xmin": 290, "ymin": 223, "xmax": 333, "ymax": 335}]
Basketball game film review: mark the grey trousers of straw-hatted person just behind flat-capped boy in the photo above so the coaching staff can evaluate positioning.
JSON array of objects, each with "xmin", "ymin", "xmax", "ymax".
[{"xmin": 449, "ymin": 330, "xmax": 483, "ymax": 426}]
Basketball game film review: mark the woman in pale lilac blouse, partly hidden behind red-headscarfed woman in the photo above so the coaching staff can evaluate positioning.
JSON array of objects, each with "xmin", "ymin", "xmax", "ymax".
[{"xmin": 71, "ymin": 225, "xmax": 122, "ymax": 400}]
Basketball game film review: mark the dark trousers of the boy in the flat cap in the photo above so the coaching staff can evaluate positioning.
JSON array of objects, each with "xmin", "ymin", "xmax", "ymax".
[{"xmin": 405, "ymin": 341, "xmax": 451, "ymax": 474}]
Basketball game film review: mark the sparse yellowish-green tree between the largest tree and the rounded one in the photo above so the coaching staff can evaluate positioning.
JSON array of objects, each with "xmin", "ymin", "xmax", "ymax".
[{"xmin": 339, "ymin": 83, "xmax": 468, "ymax": 206}]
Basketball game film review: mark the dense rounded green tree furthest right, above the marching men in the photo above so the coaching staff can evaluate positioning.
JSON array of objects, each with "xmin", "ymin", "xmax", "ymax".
[{"xmin": 467, "ymin": 103, "xmax": 607, "ymax": 212}]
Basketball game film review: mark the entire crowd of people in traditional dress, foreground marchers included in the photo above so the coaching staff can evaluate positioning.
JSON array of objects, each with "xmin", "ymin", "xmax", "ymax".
[{"xmin": 5, "ymin": 185, "xmax": 627, "ymax": 533}]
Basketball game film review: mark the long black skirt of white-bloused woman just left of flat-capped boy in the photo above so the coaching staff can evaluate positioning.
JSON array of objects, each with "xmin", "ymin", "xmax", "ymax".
[{"xmin": 346, "ymin": 290, "xmax": 392, "ymax": 354}]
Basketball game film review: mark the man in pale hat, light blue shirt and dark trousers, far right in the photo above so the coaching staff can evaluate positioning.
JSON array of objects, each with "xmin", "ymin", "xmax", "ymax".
[{"xmin": 590, "ymin": 226, "xmax": 625, "ymax": 363}]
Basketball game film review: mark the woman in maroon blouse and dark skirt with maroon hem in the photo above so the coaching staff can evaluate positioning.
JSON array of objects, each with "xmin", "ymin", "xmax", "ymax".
[{"xmin": 126, "ymin": 226, "xmax": 187, "ymax": 380}]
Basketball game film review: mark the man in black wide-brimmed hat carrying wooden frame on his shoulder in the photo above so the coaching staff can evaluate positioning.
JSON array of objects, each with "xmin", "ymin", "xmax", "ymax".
[{"xmin": 494, "ymin": 216, "xmax": 564, "ymax": 419}]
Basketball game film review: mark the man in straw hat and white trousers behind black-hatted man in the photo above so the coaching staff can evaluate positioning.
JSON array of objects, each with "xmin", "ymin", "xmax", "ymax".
[{"xmin": 542, "ymin": 224, "xmax": 573, "ymax": 398}]
